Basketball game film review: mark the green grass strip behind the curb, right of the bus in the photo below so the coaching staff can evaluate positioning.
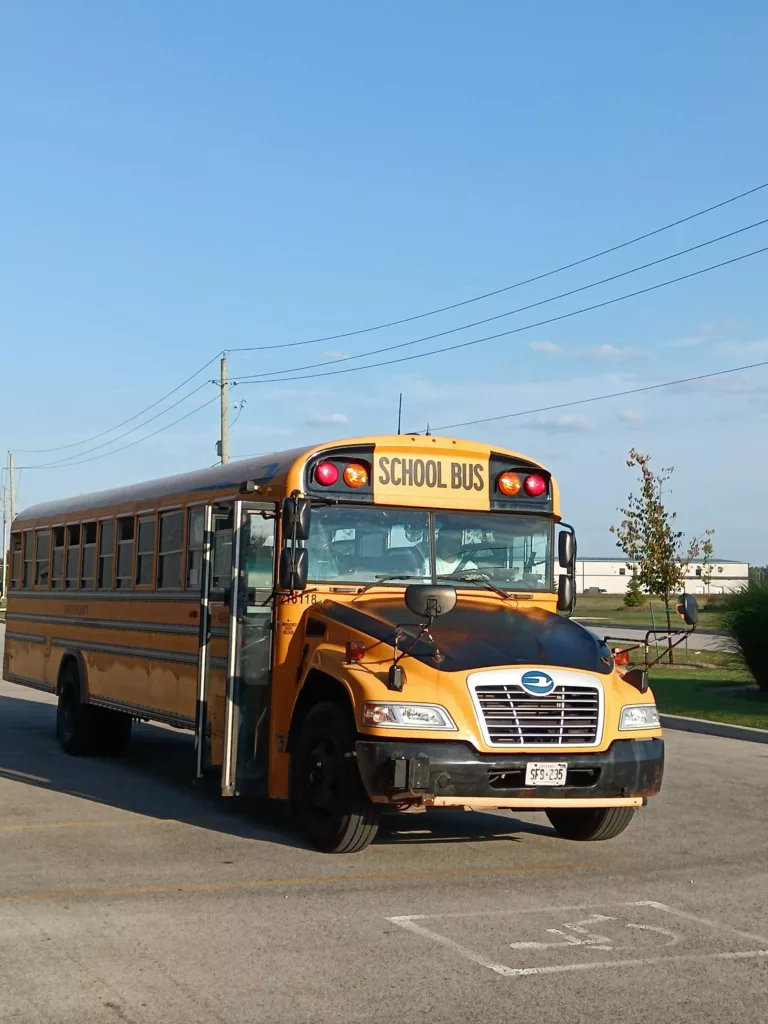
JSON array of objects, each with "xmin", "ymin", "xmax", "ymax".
[{"xmin": 649, "ymin": 667, "xmax": 768, "ymax": 729}]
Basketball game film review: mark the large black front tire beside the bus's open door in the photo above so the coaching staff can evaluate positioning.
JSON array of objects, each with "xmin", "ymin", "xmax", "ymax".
[{"xmin": 291, "ymin": 700, "xmax": 379, "ymax": 853}]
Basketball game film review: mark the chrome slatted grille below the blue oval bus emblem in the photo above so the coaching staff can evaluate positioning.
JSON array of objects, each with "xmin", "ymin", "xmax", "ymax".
[{"xmin": 471, "ymin": 680, "xmax": 602, "ymax": 746}]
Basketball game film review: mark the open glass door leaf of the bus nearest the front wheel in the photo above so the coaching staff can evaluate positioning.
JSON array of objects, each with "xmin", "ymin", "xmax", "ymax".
[{"xmin": 221, "ymin": 502, "xmax": 278, "ymax": 797}]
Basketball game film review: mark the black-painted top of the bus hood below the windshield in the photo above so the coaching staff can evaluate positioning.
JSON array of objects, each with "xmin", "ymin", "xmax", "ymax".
[{"xmin": 314, "ymin": 594, "xmax": 613, "ymax": 675}]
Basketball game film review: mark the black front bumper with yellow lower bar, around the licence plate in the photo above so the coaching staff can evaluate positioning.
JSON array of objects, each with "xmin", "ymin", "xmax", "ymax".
[{"xmin": 355, "ymin": 738, "xmax": 664, "ymax": 808}]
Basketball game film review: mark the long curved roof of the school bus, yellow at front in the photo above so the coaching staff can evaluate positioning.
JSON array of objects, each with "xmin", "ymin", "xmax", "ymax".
[{"xmin": 13, "ymin": 434, "xmax": 552, "ymax": 526}]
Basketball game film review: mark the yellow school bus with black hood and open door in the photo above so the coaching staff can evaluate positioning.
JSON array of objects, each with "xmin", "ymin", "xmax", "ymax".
[{"xmin": 3, "ymin": 435, "xmax": 664, "ymax": 852}]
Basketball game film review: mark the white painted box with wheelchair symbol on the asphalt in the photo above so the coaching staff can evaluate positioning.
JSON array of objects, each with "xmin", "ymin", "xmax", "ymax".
[{"xmin": 386, "ymin": 900, "xmax": 768, "ymax": 978}]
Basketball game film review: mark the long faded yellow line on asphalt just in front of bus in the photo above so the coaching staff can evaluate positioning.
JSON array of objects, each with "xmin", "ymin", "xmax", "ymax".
[{"xmin": 0, "ymin": 864, "xmax": 598, "ymax": 903}]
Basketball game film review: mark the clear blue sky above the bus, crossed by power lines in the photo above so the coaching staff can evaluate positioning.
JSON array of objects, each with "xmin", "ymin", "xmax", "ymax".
[{"xmin": 0, "ymin": 0, "xmax": 768, "ymax": 563}]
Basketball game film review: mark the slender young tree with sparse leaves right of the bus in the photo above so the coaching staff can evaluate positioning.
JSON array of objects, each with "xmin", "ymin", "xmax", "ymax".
[{"xmin": 610, "ymin": 449, "xmax": 700, "ymax": 665}]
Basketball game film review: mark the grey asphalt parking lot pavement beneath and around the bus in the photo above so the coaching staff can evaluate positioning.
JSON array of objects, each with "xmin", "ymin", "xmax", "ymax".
[{"xmin": 0, "ymin": 626, "xmax": 768, "ymax": 1024}]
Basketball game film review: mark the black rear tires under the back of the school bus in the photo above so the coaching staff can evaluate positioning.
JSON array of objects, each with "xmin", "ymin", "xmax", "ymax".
[{"xmin": 56, "ymin": 665, "xmax": 133, "ymax": 757}]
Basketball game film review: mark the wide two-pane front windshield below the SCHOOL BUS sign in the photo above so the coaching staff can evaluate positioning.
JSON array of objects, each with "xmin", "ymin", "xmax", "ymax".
[{"xmin": 306, "ymin": 506, "xmax": 553, "ymax": 591}]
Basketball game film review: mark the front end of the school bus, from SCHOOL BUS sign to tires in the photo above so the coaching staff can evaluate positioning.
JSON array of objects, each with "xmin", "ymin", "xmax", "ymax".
[{"xmin": 272, "ymin": 437, "xmax": 664, "ymax": 851}]
